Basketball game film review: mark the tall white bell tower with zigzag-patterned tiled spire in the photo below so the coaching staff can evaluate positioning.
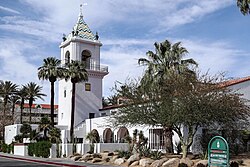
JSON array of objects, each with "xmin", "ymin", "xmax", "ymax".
[{"xmin": 58, "ymin": 12, "xmax": 108, "ymax": 129}]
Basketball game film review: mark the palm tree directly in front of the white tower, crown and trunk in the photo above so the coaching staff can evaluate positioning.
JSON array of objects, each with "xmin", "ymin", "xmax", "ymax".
[{"xmin": 64, "ymin": 60, "xmax": 88, "ymax": 142}]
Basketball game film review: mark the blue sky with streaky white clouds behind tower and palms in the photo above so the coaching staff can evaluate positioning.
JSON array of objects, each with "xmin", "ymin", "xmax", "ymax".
[{"xmin": 0, "ymin": 0, "xmax": 250, "ymax": 102}]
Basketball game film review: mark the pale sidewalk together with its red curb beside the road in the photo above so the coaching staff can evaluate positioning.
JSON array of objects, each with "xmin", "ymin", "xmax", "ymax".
[{"xmin": 0, "ymin": 152, "xmax": 116, "ymax": 167}]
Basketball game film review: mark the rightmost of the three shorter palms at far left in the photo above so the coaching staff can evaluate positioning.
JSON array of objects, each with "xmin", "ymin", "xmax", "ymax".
[{"xmin": 24, "ymin": 82, "xmax": 46, "ymax": 123}]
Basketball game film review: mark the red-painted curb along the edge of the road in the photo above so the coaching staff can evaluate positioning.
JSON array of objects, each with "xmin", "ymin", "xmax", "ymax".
[{"xmin": 0, "ymin": 155, "xmax": 87, "ymax": 167}]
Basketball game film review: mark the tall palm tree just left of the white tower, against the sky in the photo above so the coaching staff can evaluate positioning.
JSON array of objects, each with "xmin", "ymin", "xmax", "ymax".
[{"xmin": 38, "ymin": 57, "xmax": 63, "ymax": 126}]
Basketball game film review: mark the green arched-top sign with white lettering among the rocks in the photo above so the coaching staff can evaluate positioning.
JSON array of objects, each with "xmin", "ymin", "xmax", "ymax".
[{"xmin": 208, "ymin": 136, "xmax": 229, "ymax": 167}]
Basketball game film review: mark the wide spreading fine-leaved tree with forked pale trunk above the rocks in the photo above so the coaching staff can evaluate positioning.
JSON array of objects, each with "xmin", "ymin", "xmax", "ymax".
[{"xmin": 112, "ymin": 74, "xmax": 250, "ymax": 158}]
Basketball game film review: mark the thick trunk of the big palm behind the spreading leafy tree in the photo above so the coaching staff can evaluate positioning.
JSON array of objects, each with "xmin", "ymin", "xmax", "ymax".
[{"xmin": 163, "ymin": 127, "xmax": 174, "ymax": 153}]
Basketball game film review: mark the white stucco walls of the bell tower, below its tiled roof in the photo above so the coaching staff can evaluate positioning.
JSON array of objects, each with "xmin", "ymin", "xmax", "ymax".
[{"xmin": 58, "ymin": 37, "xmax": 107, "ymax": 129}]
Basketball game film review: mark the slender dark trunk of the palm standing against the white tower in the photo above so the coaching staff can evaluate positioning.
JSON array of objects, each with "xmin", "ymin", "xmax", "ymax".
[{"xmin": 70, "ymin": 82, "xmax": 76, "ymax": 143}]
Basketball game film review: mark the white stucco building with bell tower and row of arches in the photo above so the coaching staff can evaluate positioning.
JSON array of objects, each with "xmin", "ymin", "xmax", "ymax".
[{"xmin": 5, "ymin": 7, "xmax": 250, "ymax": 154}]
